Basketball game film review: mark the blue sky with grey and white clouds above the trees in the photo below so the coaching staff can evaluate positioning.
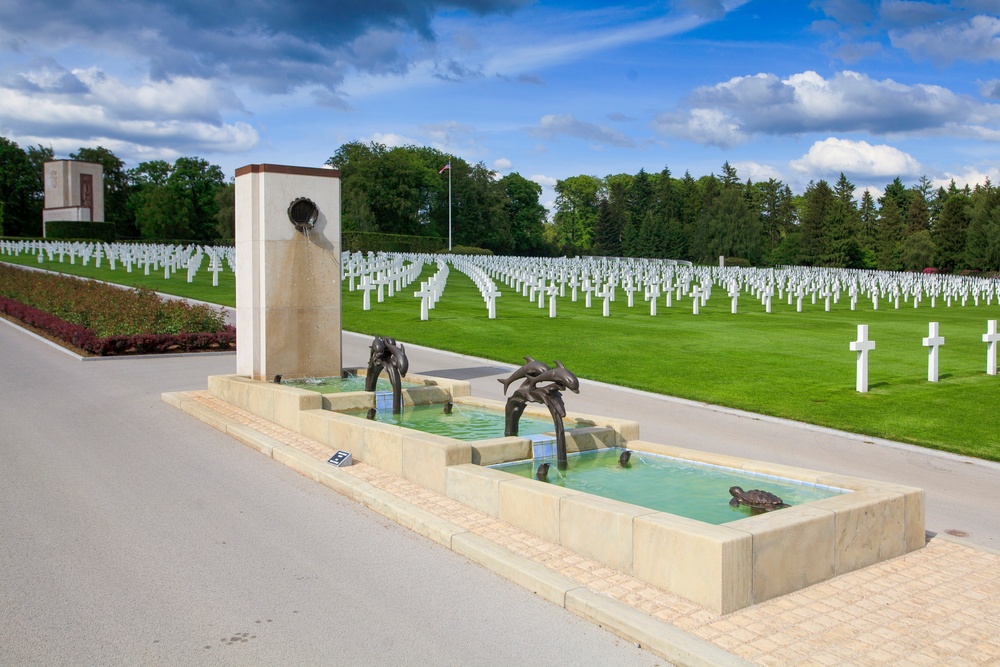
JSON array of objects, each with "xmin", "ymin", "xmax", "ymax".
[{"xmin": 0, "ymin": 0, "xmax": 1000, "ymax": 209}]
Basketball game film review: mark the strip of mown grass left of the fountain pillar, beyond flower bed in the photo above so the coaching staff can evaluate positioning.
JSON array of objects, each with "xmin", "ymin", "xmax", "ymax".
[{"xmin": 0, "ymin": 253, "xmax": 236, "ymax": 307}]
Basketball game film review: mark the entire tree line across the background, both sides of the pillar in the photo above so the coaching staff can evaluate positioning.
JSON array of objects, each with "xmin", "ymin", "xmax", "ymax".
[{"xmin": 0, "ymin": 137, "xmax": 1000, "ymax": 271}]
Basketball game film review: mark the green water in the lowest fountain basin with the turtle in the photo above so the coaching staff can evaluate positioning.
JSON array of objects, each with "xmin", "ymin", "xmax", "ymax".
[{"xmin": 493, "ymin": 449, "xmax": 843, "ymax": 525}]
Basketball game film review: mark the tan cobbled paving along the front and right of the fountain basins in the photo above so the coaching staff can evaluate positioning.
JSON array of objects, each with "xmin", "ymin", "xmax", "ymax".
[{"xmin": 187, "ymin": 391, "xmax": 1000, "ymax": 666}]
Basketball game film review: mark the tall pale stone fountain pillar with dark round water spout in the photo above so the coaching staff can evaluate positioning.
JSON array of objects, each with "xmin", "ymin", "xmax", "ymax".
[{"xmin": 236, "ymin": 164, "xmax": 341, "ymax": 380}]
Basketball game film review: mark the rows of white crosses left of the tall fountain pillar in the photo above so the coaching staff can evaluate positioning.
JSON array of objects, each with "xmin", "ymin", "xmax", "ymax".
[{"xmin": 0, "ymin": 240, "xmax": 236, "ymax": 287}]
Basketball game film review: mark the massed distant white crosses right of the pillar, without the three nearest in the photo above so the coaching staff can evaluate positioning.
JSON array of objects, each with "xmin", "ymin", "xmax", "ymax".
[{"xmin": 344, "ymin": 253, "xmax": 1000, "ymax": 319}]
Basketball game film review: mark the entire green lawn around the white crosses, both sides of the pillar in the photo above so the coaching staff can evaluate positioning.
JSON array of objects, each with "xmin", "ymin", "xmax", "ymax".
[{"xmin": 7, "ymin": 256, "xmax": 1000, "ymax": 461}]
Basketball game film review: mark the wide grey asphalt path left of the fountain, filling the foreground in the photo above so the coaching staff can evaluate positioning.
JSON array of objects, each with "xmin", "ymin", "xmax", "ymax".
[{"xmin": 0, "ymin": 321, "xmax": 663, "ymax": 667}]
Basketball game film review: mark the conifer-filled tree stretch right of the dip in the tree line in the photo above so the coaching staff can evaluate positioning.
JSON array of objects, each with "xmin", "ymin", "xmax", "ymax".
[{"xmin": 548, "ymin": 162, "xmax": 1000, "ymax": 271}]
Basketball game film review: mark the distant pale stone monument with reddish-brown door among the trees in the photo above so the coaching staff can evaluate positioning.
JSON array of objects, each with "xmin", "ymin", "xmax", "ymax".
[{"xmin": 42, "ymin": 160, "xmax": 104, "ymax": 236}]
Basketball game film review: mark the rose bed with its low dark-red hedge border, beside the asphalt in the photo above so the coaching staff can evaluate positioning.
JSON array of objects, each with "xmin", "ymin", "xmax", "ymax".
[{"xmin": 0, "ymin": 266, "xmax": 236, "ymax": 356}]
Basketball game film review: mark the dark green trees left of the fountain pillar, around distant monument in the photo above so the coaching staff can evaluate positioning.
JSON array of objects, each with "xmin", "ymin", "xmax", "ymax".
[{"xmin": 0, "ymin": 137, "xmax": 235, "ymax": 243}]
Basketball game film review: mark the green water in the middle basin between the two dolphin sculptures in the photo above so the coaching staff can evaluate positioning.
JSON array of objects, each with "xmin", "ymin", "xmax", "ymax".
[{"xmin": 344, "ymin": 403, "xmax": 568, "ymax": 441}]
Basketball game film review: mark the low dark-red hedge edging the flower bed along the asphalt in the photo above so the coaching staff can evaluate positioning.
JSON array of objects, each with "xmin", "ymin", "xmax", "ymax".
[{"xmin": 0, "ymin": 296, "xmax": 236, "ymax": 356}]
